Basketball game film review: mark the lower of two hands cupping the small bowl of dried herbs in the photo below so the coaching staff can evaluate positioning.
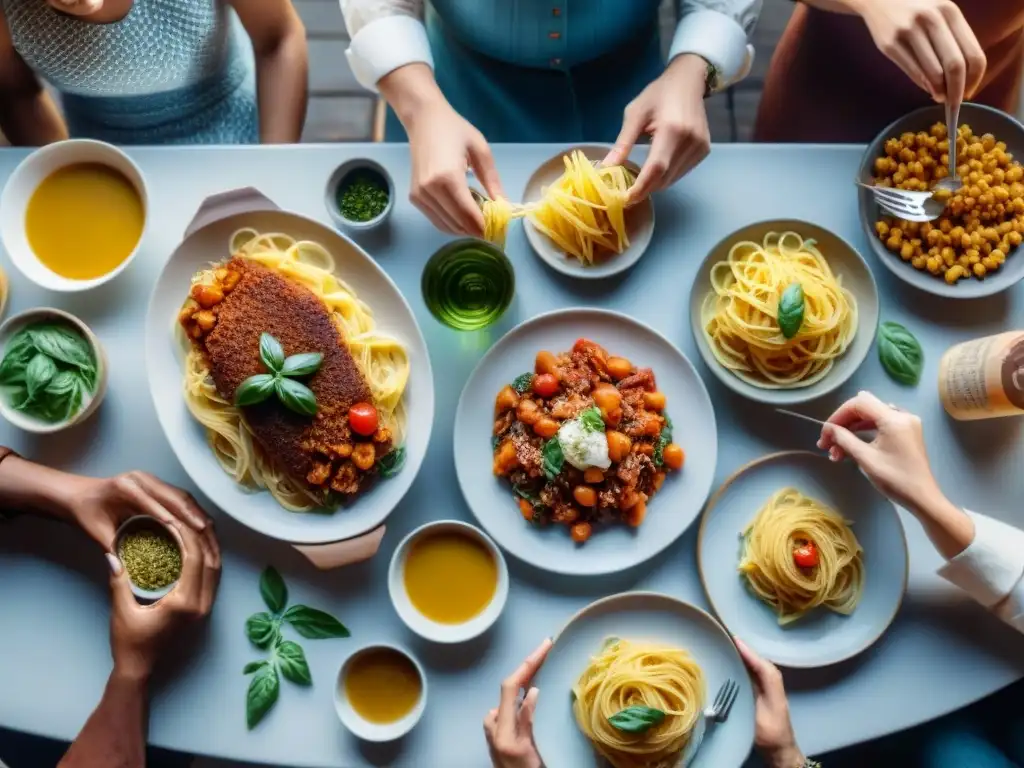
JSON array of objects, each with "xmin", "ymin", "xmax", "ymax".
[{"xmin": 106, "ymin": 520, "xmax": 220, "ymax": 679}]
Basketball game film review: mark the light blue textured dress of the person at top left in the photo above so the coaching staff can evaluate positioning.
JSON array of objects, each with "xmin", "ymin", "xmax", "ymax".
[{"xmin": 0, "ymin": 0, "xmax": 259, "ymax": 144}]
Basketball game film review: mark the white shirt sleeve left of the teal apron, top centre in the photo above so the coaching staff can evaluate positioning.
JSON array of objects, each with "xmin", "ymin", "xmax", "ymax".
[{"xmin": 341, "ymin": 0, "xmax": 434, "ymax": 91}]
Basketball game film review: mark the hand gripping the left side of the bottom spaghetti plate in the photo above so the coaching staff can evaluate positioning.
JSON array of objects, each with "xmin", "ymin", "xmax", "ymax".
[{"xmin": 483, "ymin": 638, "xmax": 552, "ymax": 768}]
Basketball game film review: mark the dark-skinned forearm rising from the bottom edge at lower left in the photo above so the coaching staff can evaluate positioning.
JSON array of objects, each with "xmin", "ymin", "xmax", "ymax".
[{"xmin": 57, "ymin": 666, "xmax": 147, "ymax": 768}]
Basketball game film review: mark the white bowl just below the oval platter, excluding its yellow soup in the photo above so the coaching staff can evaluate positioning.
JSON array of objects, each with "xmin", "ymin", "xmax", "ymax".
[{"xmin": 387, "ymin": 520, "xmax": 509, "ymax": 643}]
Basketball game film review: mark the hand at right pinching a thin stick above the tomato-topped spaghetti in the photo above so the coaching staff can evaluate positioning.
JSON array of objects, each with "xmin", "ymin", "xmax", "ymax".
[{"xmin": 818, "ymin": 392, "xmax": 941, "ymax": 511}]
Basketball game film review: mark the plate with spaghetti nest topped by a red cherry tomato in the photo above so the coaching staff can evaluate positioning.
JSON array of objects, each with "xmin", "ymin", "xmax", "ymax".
[{"xmin": 697, "ymin": 451, "xmax": 908, "ymax": 667}]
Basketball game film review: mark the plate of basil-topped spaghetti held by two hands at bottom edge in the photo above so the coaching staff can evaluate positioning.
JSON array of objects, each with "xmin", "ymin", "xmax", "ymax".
[{"xmin": 534, "ymin": 592, "xmax": 754, "ymax": 768}]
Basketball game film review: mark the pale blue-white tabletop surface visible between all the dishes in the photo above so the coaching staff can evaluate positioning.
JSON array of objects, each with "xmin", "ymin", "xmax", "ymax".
[{"xmin": 0, "ymin": 144, "xmax": 1024, "ymax": 768}]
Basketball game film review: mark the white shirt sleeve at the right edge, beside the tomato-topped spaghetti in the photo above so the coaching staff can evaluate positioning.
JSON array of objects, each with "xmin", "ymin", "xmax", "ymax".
[{"xmin": 939, "ymin": 512, "xmax": 1024, "ymax": 632}]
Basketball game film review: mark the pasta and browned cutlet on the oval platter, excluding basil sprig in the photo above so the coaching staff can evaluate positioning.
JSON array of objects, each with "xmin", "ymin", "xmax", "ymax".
[{"xmin": 178, "ymin": 229, "xmax": 409, "ymax": 512}]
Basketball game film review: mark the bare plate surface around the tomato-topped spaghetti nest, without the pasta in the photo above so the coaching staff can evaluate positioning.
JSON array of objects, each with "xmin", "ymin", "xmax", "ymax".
[{"xmin": 697, "ymin": 451, "xmax": 909, "ymax": 667}]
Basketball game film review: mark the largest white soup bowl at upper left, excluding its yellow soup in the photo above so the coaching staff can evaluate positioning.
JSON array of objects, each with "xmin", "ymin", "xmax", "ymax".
[{"xmin": 0, "ymin": 139, "xmax": 150, "ymax": 293}]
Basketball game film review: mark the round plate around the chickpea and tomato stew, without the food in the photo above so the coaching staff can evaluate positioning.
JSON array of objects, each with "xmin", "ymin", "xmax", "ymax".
[{"xmin": 455, "ymin": 309, "xmax": 718, "ymax": 575}]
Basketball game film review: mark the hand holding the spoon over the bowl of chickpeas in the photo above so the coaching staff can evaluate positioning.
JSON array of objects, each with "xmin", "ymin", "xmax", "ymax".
[{"xmin": 854, "ymin": 0, "xmax": 987, "ymax": 103}]
